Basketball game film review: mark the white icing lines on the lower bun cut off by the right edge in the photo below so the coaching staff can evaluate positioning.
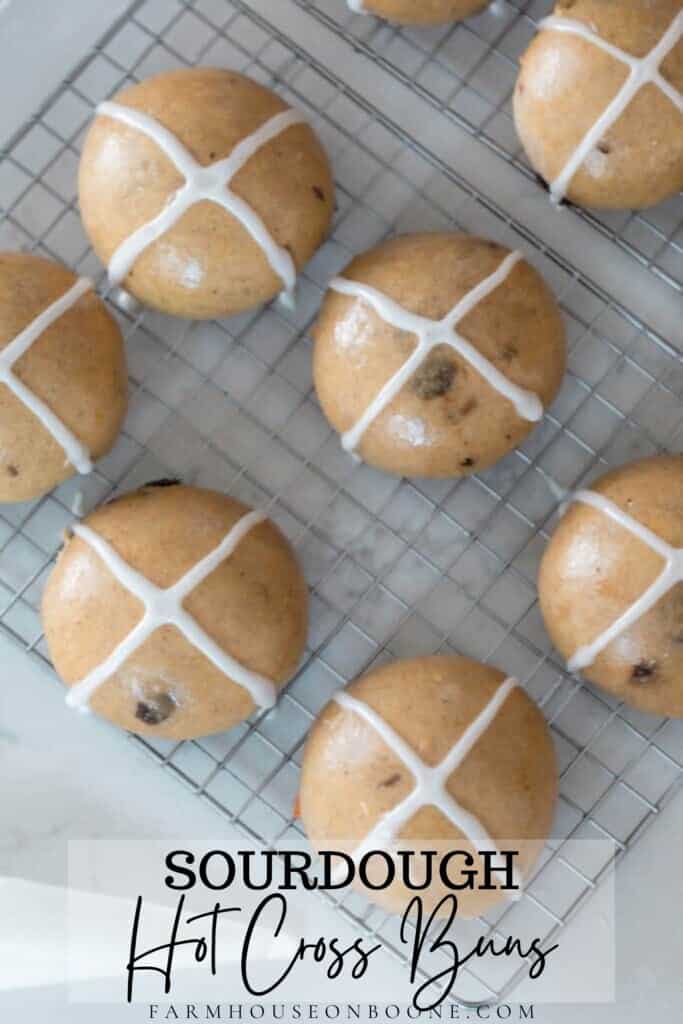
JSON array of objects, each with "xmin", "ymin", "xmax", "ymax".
[{"xmin": 567, "ymin": 490, "xmax": 683, "ymax": 672}]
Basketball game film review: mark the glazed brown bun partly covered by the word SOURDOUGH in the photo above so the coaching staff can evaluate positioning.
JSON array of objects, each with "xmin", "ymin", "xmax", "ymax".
[{"xmin": 299, "ymin": 655, "xmax": 557, "ymax": 916}]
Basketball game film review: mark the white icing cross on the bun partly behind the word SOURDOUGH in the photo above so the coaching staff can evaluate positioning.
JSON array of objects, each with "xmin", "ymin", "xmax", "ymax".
[{"xmin": 333, "ymin": 679, "xmax": 521, "ymax": 888}]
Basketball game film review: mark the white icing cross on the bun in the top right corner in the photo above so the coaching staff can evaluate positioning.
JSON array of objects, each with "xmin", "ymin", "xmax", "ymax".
[{"xmin": 539, "ymin": 11, "xmax": 683, "ymax": 203}]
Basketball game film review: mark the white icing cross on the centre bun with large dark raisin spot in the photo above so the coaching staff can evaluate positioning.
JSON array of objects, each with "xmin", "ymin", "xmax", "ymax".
[{"xmin": 330, "ymin": 252, "xmax": 543, "ymax": 452}]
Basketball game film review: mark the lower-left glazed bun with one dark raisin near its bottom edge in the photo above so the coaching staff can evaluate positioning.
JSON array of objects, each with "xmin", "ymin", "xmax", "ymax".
[{"xmin": 43, "ymin": 481, "xmax": 307, "ymax": 739}]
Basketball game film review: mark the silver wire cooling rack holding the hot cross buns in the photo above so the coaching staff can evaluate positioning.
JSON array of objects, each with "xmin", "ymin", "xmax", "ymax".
[{"xmin": 0, "ymin": 0, "xmax": 683, "ymax": 1002}]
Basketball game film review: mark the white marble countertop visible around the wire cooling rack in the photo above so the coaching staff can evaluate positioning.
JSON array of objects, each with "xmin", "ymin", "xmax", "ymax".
[{"xmin": 0, "ymin": 0, "xmax": 683, "ymax": 1024}]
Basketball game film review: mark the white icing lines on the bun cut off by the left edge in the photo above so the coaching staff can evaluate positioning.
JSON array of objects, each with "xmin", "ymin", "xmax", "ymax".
[{"xmin": 0, "ymin": 278, "xmax": 93, "ymax": 473}]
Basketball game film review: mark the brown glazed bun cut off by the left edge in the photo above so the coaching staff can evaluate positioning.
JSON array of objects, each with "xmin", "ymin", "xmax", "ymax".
[{"xmin": 0, "ymin": 252, "xmax": 128, "ymax": 502}]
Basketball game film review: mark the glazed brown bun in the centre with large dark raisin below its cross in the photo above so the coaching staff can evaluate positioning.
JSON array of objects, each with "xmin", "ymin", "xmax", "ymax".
[{"xmin": 313, "ymin": 233, "xmax": 565, "ymax": 477}]
